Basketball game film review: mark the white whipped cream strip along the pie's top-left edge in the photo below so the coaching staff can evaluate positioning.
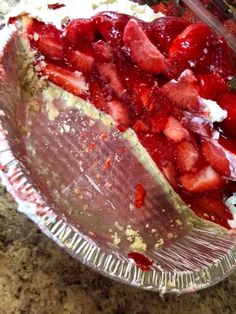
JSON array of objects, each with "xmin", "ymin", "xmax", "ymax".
[{"xmin": 7, "ymin": 0, "xmax": 163, "ymax": 29}]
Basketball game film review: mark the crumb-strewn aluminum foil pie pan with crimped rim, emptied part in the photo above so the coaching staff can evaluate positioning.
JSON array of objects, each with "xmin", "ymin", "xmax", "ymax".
[{"xmin": 0, "ymin": 3, "xmax": 236, "ymax": 293}]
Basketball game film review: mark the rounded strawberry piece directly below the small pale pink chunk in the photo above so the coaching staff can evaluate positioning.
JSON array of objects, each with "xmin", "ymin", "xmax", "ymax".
[{"xmin": 176, "ymin": 142, "xmax": 199, "ymax": 172}]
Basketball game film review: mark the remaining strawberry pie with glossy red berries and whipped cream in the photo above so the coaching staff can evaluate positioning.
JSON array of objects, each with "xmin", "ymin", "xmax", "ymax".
[{"xmin": 9, "ymin": 0, "xmax": 236, "ymax": 228}]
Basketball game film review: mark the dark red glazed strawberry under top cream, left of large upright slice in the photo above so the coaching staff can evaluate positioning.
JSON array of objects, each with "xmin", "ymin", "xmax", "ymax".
[{"xmin": 93, "ymin": 12, "xmax": 131, "ymax": 47}]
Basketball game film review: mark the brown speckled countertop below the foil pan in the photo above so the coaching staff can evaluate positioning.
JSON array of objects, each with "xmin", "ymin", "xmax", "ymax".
[{"xmin": 0, "ymin": 187, "xmax": 236, "ymax": 314}]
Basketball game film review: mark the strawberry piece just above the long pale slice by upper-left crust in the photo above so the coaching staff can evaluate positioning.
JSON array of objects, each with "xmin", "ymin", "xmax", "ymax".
[{"xmin": 65, "ymin": 47, "xmax": 94, "ymax": 73}]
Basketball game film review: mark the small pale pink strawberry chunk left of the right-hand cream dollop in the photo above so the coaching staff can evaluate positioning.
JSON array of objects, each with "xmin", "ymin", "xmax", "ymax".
[{"xmin": 164, "ymin": 116, "xmax": 189, "ymax": 142}]
